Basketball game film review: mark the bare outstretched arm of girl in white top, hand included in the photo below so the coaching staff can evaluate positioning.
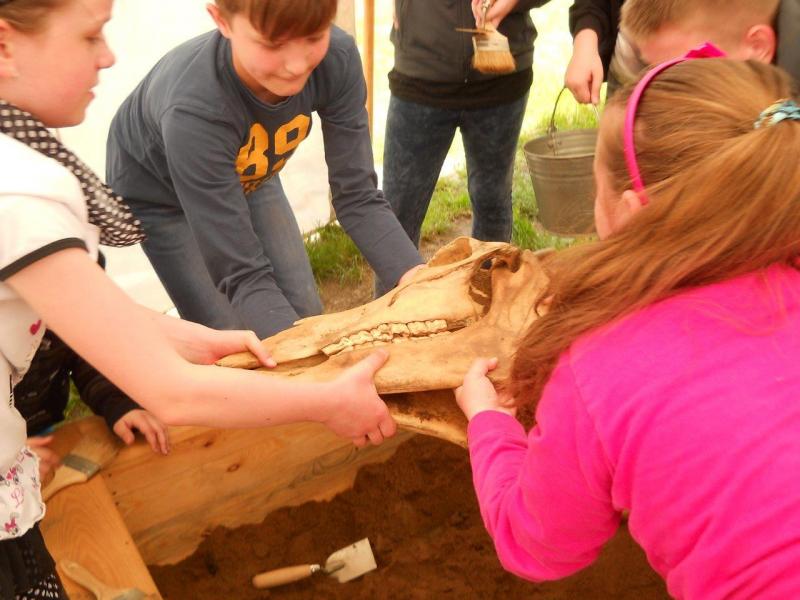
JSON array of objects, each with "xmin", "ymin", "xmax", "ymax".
[{"xmin": 6, "ymin": 248, "xmax": 396, "ymax": 443}]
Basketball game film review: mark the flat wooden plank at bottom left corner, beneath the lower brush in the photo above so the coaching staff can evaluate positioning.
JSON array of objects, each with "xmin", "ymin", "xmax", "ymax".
[{"xmin": 41, "ymin": 477, "xmax": 161, "ymax": 600}]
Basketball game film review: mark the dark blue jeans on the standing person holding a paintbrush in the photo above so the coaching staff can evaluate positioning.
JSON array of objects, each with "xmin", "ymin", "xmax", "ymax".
[{"xmin": 383, "ymin": 94, "xmax": 528, "ymax": 246}]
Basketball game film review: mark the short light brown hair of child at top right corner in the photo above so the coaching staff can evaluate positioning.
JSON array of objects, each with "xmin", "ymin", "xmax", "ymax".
[{"xmin": 620, "ymin": 0, "xmax": 780, "ymax": 39}]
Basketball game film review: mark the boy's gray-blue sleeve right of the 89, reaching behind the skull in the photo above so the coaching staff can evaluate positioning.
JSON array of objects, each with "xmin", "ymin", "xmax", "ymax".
[{"xmin": 318, "ymin": 39, "xmax": 424, "ymax": 287}]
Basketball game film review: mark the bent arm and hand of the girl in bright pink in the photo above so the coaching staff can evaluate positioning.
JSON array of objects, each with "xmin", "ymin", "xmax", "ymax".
[{"xmin": 459, "ymin": 361, "xmax": 620, "ymax": 581}]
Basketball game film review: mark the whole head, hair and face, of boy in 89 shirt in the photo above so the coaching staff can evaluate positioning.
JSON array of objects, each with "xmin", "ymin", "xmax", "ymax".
[{"xmin": 208, "ymin": 0, "xmax": 337, "ymax": 99}]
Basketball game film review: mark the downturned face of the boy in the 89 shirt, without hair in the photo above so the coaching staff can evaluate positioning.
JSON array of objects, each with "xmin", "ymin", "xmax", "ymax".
[{"xmin": 217, "ymin": 14, "xmax": 330, "ymax": 102}]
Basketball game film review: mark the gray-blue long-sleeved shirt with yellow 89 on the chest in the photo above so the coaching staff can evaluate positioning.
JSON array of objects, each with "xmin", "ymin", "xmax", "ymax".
[{"xmin": 106, "ymin": 27, "xmax": 422, "ymax": 332}]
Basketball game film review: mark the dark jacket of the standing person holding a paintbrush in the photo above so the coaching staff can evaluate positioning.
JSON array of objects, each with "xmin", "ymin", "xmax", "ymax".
[{"xmin": 391, "ymin": 0, "xmax": 548, "ymax": 83}]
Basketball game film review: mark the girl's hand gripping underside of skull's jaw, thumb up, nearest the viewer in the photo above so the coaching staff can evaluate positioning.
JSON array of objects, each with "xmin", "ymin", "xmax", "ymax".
[{"xmin": 322, "ymin": 350, "xmax": 397, "ymax": 447}]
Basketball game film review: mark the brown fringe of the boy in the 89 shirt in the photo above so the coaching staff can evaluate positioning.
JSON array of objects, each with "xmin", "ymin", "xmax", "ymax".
[{"xmin": 215, "ymin": 0, "xmax": 338, "ymax": 39}]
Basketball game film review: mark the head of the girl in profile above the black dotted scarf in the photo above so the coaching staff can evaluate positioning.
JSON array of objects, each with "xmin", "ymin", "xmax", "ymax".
[{"xmin": 0, "ymin": 0, "xmax": 114, "ymax": 127}]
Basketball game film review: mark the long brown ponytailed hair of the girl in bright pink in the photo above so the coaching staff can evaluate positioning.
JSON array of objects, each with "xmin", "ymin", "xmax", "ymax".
[{"xmin": 508, "ymin": 59, "xmax": 800, "ymax": 404}]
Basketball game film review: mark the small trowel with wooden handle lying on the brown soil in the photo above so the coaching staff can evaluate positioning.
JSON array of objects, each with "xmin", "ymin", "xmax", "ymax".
[{"xmin": 253, "ymin": 538, "xmax": 378, "ymax": 589}]
